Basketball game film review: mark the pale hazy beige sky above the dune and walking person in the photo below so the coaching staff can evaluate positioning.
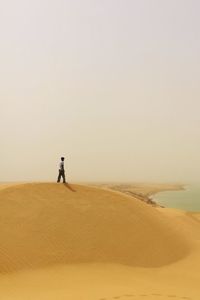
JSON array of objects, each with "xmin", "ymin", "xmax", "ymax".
[{"xmin": 0, "ymin": 0, "xmax": 200, "ymax": 182}]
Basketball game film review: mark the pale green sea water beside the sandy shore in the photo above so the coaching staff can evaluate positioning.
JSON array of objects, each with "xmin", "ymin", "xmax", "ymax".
[{"xmin": 153, "ymin": 184, "xmax": 200, "ymax": 212}]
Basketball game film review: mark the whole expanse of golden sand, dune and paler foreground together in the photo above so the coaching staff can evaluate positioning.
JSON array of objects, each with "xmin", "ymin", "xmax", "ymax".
[{"xmin": 0, "ymin": 183, "xmax": 200, "ymax": 300}]
